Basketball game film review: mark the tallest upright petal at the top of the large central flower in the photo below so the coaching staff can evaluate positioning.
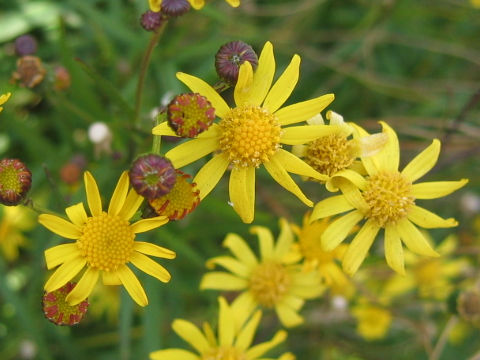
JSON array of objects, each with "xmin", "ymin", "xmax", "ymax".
[{"xmin": 248, "ymin": 41, "xmax": 275, "ymax": 106}]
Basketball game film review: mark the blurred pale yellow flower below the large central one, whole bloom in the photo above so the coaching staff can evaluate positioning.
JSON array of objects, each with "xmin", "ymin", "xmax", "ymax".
[{"xmin": 200, "ymin": 219, "xmax": 324, "ymax": 327}]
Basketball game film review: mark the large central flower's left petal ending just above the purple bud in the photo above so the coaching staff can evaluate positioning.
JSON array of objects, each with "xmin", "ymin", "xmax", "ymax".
[{"xmin": 165, "ymin": 138, "xmax": 219, "ymax": 169}]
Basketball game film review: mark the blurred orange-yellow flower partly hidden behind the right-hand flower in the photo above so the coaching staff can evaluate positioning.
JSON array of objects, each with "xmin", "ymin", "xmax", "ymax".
[{"xmin": 290, "ymin": 213, "xmax": 354, "ymax": 296}]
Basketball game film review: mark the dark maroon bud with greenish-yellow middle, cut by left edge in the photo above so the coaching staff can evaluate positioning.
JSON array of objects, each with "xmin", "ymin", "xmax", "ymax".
[{"xmin": 0, "ymin": 159, "xmax": 32, "ymax": 206}]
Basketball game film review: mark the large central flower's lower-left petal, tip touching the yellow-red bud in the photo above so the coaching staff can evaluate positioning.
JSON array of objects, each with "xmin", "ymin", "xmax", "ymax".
[{"xmin": 193, "ymin": 153, "xmax": 230, "ymax": 200}]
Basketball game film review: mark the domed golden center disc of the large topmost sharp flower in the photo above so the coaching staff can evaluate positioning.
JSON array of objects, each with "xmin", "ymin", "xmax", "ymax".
[{"xmin": 219, "ymin": 106, "xmax": 281, "ymax": 167}]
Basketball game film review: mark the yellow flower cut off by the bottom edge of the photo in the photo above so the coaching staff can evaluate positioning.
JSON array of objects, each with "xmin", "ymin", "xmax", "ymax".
[{"xmin": 150, "ymin": 297, "xmax": 295, "ymax": 360}]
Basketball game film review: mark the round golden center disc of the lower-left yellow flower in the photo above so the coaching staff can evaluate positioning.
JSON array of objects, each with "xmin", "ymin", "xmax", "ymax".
[{"xmin": 77, "ymin": 212, "xmax": 135, "ymax": 271}]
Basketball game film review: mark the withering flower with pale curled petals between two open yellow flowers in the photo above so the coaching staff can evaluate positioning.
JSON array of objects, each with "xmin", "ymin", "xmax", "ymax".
[{"xmin": 293, "ymin": 111, "xmax": 388, "ymax": 185}]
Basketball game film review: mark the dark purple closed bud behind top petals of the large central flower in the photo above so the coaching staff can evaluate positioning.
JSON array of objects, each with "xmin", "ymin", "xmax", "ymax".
[{"xmin": 215, "ymin": 41, "xmax": 258, "ymax": 85}]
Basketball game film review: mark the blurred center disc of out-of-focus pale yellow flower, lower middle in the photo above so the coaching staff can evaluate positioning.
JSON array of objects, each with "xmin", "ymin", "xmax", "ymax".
[{"xmin": 249, "ymin": 262, "xmax": 290, "ymax": 307}]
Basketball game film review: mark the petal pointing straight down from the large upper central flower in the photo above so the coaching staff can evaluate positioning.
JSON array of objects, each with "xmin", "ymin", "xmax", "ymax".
[{"xmin": 229, "ymin": 167, "xmax": 255, "ymax": 224}]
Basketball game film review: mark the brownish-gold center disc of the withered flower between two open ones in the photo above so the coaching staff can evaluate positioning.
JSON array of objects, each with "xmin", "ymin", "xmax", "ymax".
[{"xmin": 305, "ymin": 134, "xmax": 358, "ymax": 176}]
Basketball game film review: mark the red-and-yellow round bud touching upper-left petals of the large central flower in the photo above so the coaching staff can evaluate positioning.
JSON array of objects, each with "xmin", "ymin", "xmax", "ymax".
[{"xmin": 167, "ymin": 93, "xmax": 215, "ymax": 138}]
